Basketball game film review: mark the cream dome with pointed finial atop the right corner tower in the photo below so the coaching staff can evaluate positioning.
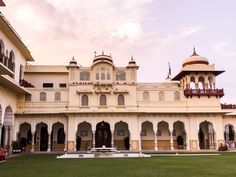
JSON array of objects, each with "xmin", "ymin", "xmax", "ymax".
[{"xmin": 182, "ymin": 48, "xmax": 209, "ymax": 67}]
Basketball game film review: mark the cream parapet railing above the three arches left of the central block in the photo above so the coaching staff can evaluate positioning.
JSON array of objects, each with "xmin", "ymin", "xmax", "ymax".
[{"xmin": 17, "ymin": 101, "xmax": 69, "ymax": 109}]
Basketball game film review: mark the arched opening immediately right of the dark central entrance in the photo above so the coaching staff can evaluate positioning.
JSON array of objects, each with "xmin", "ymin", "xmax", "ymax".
[{"xmin": 114, "ymin": 121, "xmax": 130, "ymax": 150}]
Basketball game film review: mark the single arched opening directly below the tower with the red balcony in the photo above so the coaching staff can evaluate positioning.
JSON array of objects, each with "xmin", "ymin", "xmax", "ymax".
[{"xmin": 198, "ymin": 121, "xmax": 215, "ymax": 149}]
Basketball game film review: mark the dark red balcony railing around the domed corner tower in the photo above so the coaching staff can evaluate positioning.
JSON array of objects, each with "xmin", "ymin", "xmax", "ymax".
[{"xmin": 184, "ymin": 89, "xmax": 224, "ymax": 98}]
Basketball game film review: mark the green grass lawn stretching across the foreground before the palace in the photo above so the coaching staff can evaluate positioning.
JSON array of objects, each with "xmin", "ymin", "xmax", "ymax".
[{"xmin": 0, "ymin": 153, "xmax": 236, "ymax": 177}]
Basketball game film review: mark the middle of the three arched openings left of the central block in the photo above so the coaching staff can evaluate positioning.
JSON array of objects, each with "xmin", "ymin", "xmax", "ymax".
[{"xmin": 35, "ymin": 122, "xmax": 48, "ymax": 151}]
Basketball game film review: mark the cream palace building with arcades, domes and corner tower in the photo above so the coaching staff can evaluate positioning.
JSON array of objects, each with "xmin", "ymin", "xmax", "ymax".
[{"xmin": 0, "ymin": 11, "xmax": 236, "ymax": 152}]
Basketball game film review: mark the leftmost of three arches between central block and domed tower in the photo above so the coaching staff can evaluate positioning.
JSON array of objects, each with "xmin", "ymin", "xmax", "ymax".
[{"xmin": 140, "ymin": 121, "xmax": 155, "ymax": 150}]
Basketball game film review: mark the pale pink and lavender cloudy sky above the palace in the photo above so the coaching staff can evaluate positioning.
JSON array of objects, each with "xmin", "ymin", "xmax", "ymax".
[{"xmin": 0, "ymin": 0, "xmax": 236, "ymax": 103}]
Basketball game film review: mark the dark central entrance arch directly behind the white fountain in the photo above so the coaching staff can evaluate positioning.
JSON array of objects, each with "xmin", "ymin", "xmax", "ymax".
[{"xmin": 95, "ymin": 121, "xmax": 111, "ymax": 147}]
